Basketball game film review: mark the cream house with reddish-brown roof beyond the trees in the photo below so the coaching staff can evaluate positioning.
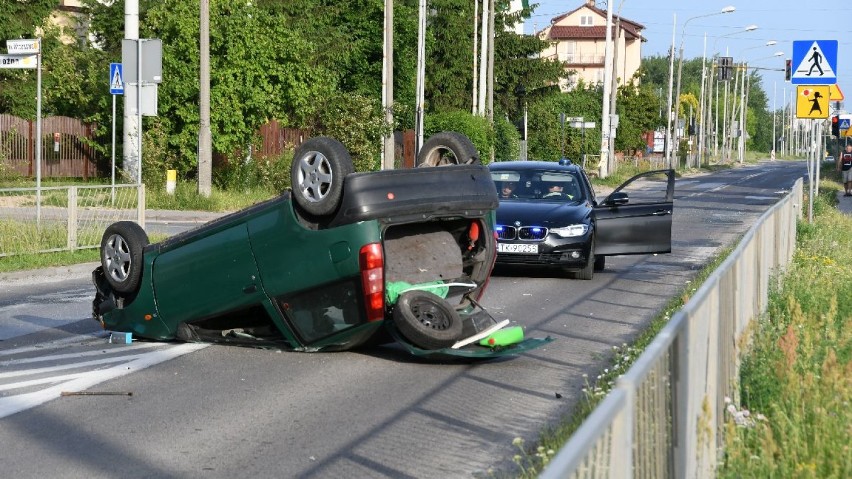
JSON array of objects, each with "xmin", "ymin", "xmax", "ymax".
[{"xmin": 536, "ymin": 0, "xmax": 645, "ymax": 91}]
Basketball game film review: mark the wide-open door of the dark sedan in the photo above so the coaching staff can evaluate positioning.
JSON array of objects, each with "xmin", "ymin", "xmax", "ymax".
[{"xmin": 594, "ymin": 170, "xmax": 674, "ymax": 255}]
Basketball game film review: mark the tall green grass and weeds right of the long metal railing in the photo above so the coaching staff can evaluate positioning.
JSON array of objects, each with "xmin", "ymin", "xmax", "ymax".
[{"xmin": 718, "ymin": 175, "xmax": 852, "ymax": 478}]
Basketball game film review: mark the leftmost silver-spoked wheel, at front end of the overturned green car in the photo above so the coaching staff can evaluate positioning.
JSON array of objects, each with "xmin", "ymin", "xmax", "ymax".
[{"xmin": 101, "ymin": 221, "xmax": 148, "ymax": 294}]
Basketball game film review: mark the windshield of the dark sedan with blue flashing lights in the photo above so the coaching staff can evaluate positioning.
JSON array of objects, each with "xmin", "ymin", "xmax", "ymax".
[{"xmin": 491, "ymin": 170, "xmax": 586, "ymax": 202}]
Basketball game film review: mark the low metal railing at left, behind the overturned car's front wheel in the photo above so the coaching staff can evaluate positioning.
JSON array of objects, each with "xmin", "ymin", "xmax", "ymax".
[{"xmin": 0, "ymin": 185, "xmax": 145, "ymax": 257}]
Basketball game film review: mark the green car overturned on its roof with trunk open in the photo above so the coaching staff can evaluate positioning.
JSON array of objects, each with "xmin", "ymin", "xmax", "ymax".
[{"xmin": 92, "ymin": 132, "xmax": 550, "ymax": 359}]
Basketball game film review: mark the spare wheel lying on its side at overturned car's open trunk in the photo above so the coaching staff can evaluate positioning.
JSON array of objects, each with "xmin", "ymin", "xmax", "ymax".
[{"xmin": 393, "ymin": 291, "xmax": 462, "ymax": 349}]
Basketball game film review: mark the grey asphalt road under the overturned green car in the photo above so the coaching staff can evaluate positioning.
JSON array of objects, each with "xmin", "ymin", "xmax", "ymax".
[{"xmin": 0, "ymin": 162, "xmax": 806, "ymax": 478}]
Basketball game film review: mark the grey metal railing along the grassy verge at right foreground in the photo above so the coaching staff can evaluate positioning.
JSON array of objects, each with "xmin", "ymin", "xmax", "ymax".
[{"xmin": 539, "ymin": 179, "xmax": 802, "ymax": 479}]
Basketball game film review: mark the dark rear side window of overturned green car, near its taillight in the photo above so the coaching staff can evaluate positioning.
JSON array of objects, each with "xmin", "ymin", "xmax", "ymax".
[{"xmin": 275, "ymin": 279, "xmax": 364, "ymax": 344}]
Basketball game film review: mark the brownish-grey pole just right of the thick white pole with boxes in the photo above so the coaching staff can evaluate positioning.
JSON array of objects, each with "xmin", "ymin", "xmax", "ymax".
[{"xmin": 198, "ymin": 0, "xmax": 213, "ymax": 198}]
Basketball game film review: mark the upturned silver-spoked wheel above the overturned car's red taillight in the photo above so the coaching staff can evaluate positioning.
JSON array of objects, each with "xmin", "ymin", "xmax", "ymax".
[{"xmin": 290, "ymin": 136, "xmax": 354, "ymax": 216}]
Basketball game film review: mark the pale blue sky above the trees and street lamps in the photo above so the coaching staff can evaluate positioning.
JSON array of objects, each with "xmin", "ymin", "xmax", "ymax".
[{"xmin": 524, "ymin": 0, "xmax": 852, "ymax": 109}]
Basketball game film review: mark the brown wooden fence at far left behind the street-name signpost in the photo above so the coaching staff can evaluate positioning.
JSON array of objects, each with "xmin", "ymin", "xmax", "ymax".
[{"xmin": 0, "ymin": 114, "xmax": 98, "ymax": 180}]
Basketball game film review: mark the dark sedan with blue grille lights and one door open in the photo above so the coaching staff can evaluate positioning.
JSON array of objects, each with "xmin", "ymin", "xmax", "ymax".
[{"xmin": 489, "ymin": 160, "xmax": 674, "ymax": 279}]
